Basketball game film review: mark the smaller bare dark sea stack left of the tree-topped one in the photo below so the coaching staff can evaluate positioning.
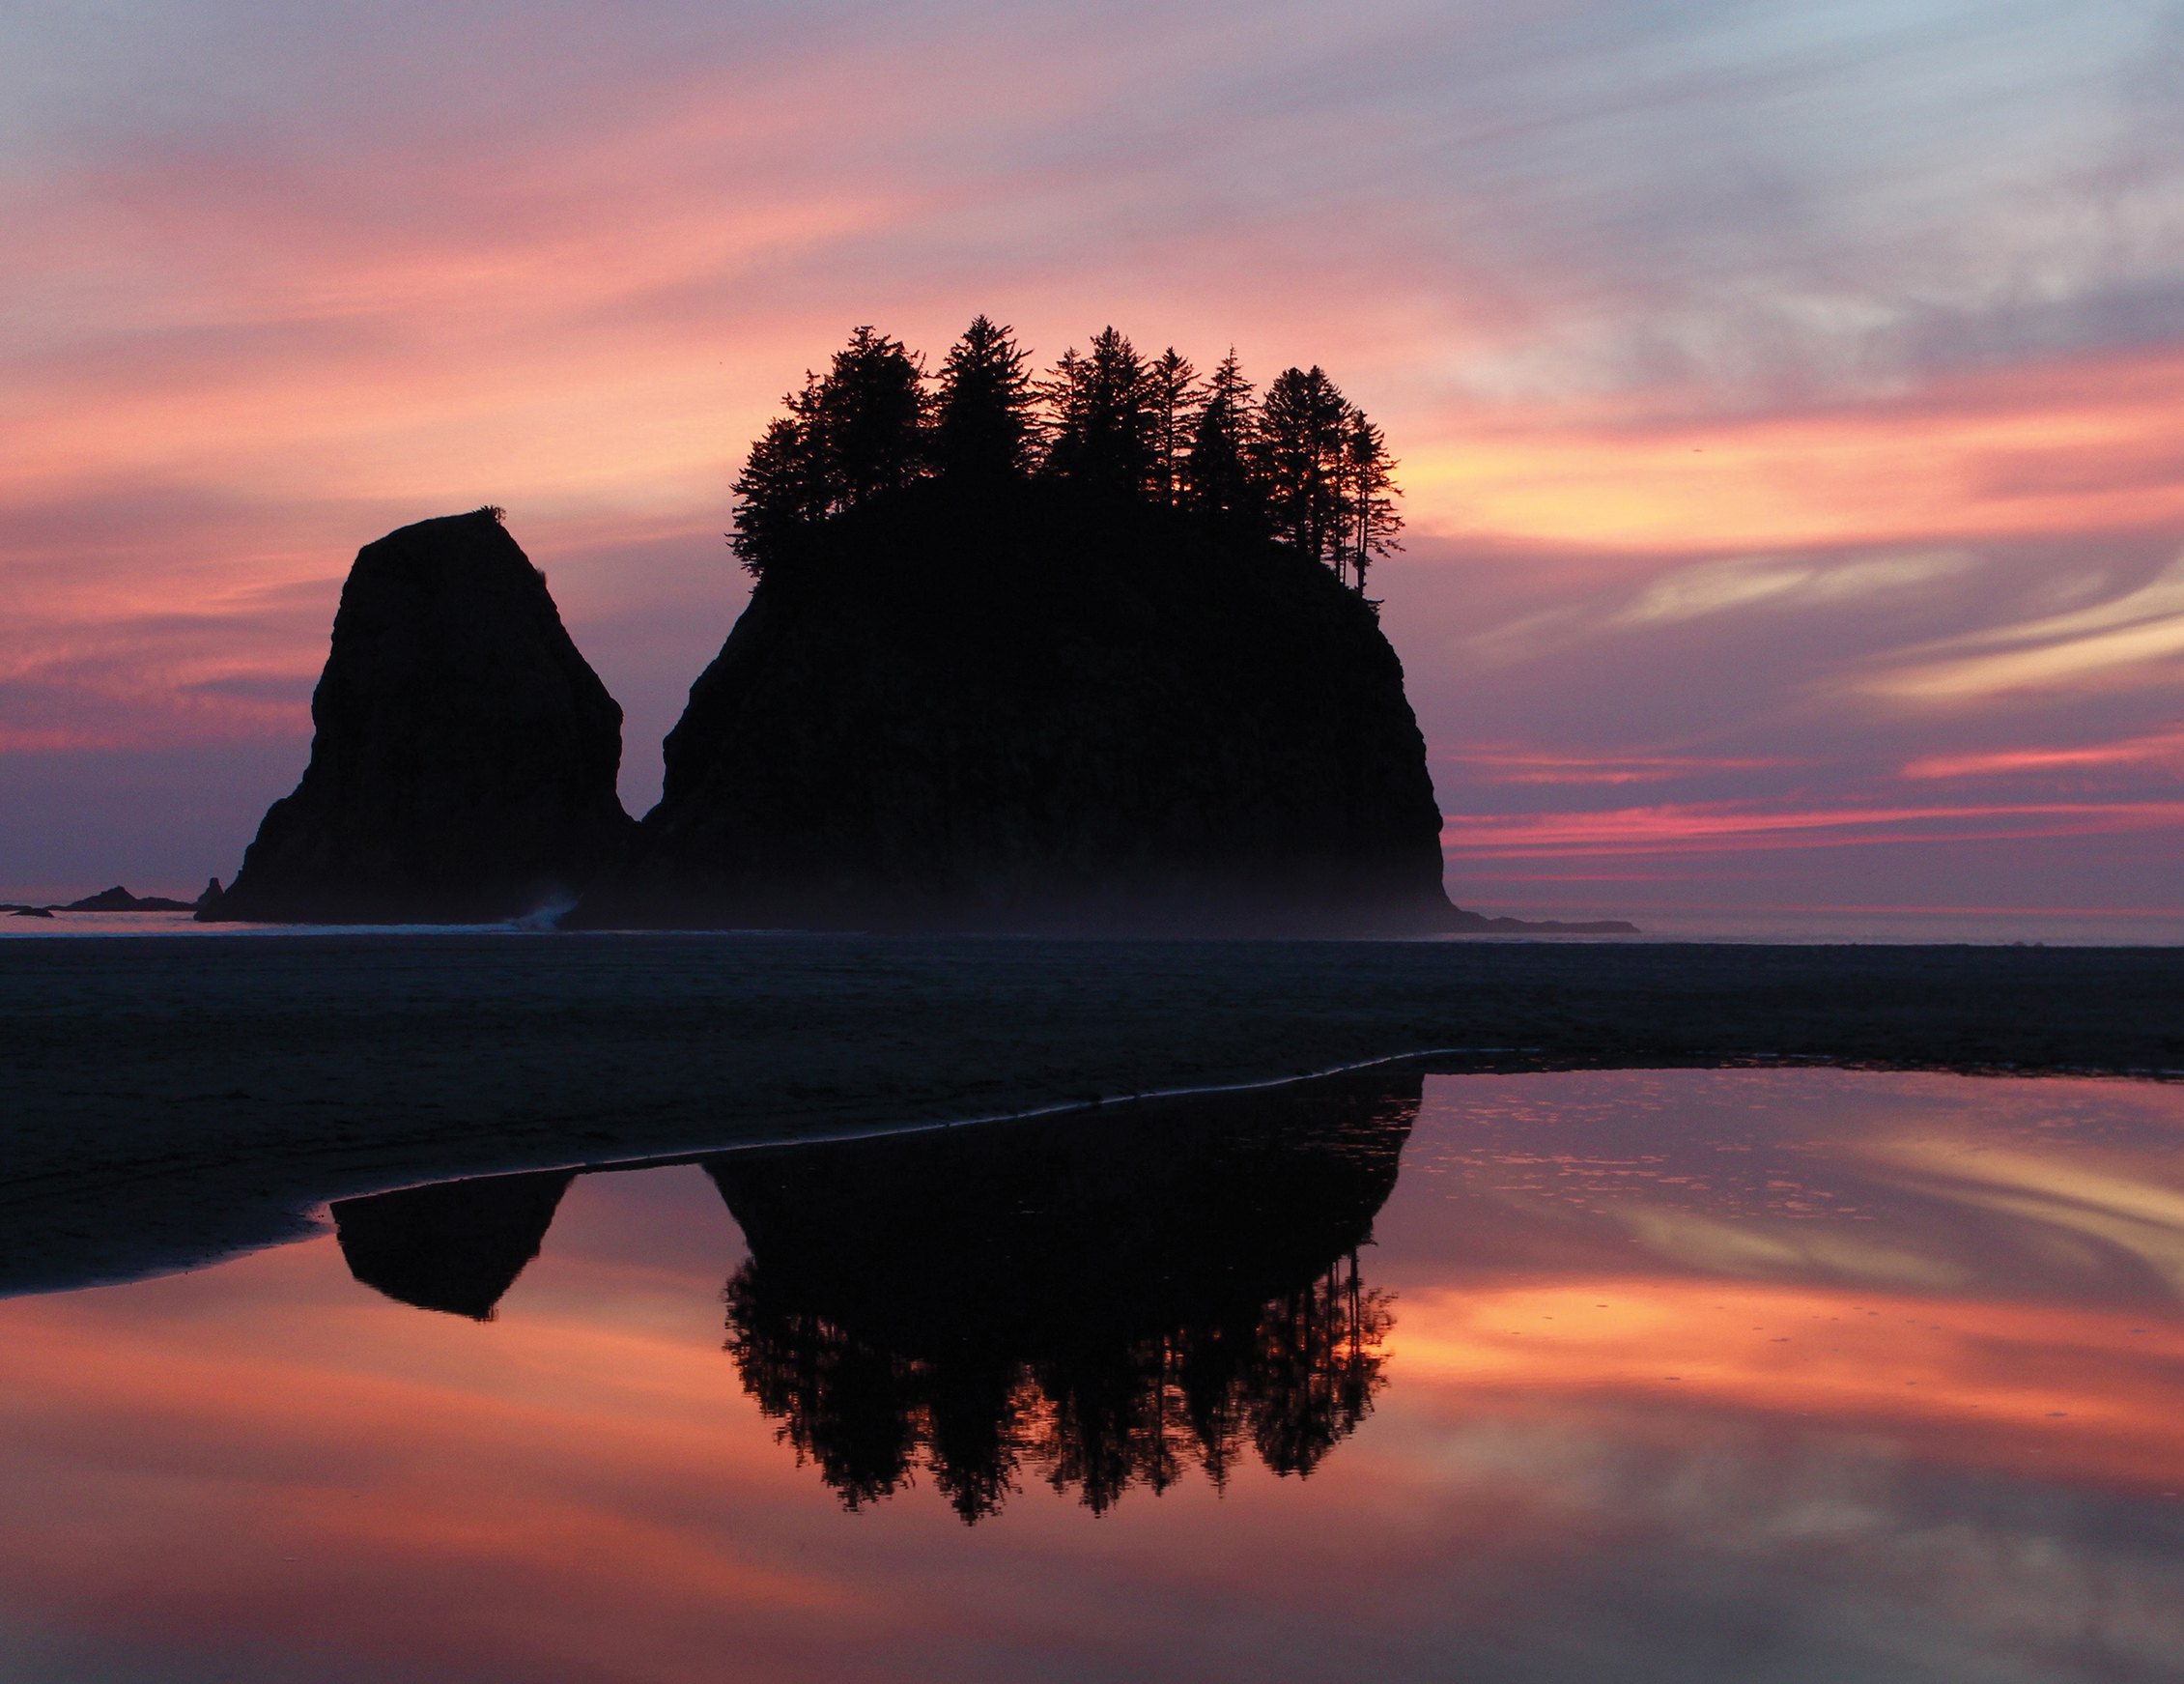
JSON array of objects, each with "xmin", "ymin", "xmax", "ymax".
[{"xmin": 199, "ymin": 509, "xmax": 636, "ymax": 922}]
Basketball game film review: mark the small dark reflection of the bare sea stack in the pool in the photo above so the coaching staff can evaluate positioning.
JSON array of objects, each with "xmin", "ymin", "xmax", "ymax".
[{"xmin": 332, "ymin": 1171, "xmax": 575, "ymax": 1322}]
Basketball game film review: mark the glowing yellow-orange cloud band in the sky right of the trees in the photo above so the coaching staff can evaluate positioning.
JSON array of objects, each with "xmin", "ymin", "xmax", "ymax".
[{"xmin": 1404, "ymin": 350, "xmax": 2184, "ymax": 551}]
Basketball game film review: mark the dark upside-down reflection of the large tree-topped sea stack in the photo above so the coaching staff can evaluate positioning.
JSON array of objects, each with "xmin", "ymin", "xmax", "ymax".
[{"xmin": 708, "ymin": 1077, "xmax": 1420, "ymax": 1520}]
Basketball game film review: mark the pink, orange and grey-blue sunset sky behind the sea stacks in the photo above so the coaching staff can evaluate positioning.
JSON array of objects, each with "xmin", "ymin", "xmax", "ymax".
[{"xmin": 0, "ymin": 0, "xmax": 2184, "ymax": 928}]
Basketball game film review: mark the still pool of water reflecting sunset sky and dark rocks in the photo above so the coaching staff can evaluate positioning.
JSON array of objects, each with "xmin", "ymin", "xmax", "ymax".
[{"xmin": 0, "ymin": 1070, "xmax": 2184, "ymax": 1684}]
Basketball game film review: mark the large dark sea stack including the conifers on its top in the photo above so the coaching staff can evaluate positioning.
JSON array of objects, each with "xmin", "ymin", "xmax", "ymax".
[{"xmin": 603, "ymin": 317, "xmax": 1476, "ymax": 932}]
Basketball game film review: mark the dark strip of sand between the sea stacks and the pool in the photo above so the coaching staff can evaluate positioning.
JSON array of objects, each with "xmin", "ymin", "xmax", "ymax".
[{"xmin": 0, "ymin": 935, "xmax": 2184, "ymax": 1293}]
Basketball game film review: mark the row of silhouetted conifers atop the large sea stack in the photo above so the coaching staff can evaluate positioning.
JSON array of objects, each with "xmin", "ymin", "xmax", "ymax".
[{"xmin": 729, "ymin": 315, "xmax": 1403, "ymax": 594}]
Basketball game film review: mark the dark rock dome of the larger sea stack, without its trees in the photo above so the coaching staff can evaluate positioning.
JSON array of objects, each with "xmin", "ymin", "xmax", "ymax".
[{"xmin": 603, "ymin": 485, "xmax": 1457, "ymax": 932}]
